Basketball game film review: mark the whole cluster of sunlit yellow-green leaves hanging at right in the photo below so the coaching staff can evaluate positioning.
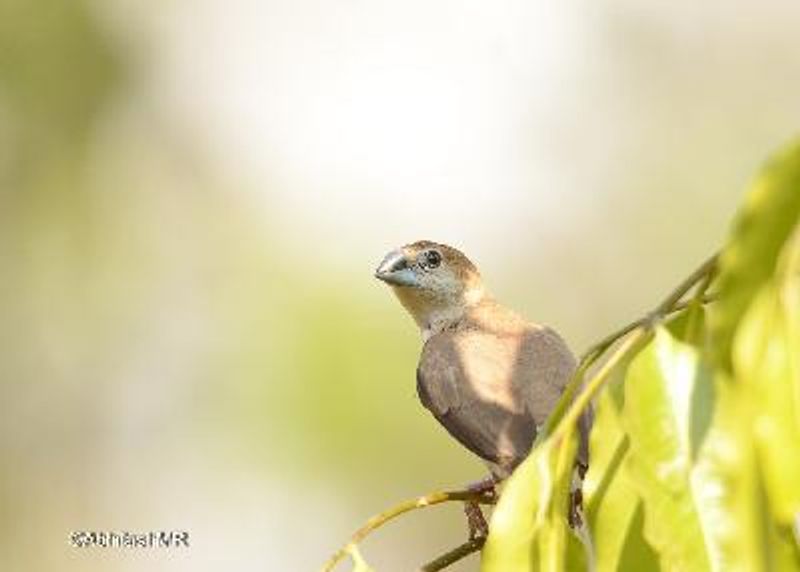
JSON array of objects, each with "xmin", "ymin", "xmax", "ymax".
[{"xmin": 481, "ymin": 140, "xmax": 800, "ymax": 572}]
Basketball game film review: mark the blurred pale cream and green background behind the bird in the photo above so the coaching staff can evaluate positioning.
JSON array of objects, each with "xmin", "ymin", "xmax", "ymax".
[{"xmin": 0, "ymin": 0, "xmax": 800, "ymax": 571}]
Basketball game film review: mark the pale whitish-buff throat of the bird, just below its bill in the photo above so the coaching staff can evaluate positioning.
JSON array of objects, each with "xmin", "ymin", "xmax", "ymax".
[{"xmin": 394, "ymin": 287, "xmax": 485, "ymax": 341}]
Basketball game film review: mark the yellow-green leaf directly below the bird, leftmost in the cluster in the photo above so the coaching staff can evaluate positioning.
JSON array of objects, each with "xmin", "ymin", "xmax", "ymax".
[{"xmin": 481, "ymin": 431, "xmax": 585, "ymax": 572}]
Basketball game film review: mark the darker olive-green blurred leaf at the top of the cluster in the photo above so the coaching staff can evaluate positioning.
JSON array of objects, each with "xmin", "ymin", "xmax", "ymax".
[{"xmin": 714, "ymin": 143, "xmax": 800, "ymax": 371}]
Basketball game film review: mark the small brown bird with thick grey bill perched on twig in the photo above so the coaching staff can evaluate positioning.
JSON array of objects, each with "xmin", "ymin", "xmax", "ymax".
[{"xmin": 375, "ymin": 240, "xmax": 591, "ymax": 538}]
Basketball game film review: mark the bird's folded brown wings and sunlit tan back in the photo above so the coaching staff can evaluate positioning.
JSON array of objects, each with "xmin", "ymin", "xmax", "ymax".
[{"xmin": 417, "ymin": 328, "xmax": 588, "ymax": 468}]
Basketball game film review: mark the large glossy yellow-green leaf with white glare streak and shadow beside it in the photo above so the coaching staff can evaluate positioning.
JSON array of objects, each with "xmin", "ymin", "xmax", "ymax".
[{"xmin": 622, "ymin": 329, "xmax": 800, "ymax": 572}]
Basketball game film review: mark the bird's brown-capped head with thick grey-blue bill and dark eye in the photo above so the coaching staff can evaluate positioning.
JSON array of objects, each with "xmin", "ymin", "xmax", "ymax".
[{"xmin": 375, "ymin": 240, "xmax": 484, "ymax": 335}]
